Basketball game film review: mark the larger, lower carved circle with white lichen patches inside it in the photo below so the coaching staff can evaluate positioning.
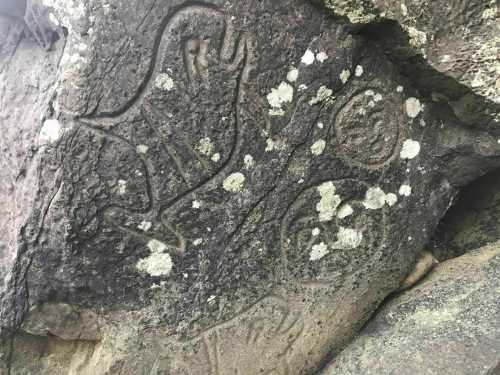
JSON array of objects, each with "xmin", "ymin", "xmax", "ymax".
[{"xmin": 281, "ymin": 179, "xmax": 387, "ymax": 284}]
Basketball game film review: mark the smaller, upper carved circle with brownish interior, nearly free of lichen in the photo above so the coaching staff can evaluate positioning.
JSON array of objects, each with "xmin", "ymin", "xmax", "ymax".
[{"xmin": 334, "ymin": 89, "xmax": 403, "ymax": 167}]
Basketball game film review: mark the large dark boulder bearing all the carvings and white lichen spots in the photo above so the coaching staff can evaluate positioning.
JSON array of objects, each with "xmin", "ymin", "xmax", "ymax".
[{"xmin": 0, "ymin": 0, "xmax": 500, "ymax": 375}]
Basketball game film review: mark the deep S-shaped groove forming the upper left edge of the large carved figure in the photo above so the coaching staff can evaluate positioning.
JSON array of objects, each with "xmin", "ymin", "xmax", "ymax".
[{"xmin": 81, "ymin": 1, "xmax": 223, "ymax": 119}]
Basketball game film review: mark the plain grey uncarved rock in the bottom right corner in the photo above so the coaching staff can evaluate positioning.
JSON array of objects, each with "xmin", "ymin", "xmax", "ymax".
[{"xmin": 322, "ymin": 242, "xmax": 500, "ymax": 375}]
